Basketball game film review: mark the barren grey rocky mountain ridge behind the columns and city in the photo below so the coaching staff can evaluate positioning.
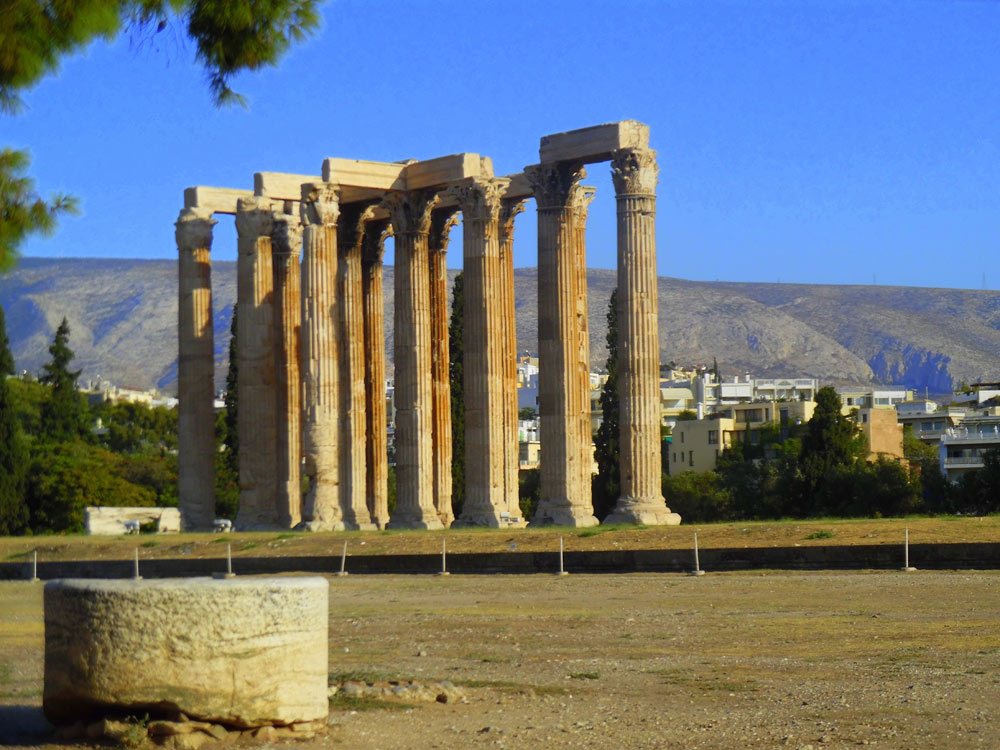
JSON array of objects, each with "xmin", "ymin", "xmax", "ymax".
[{"xmin": 0, "ymin": 258, "xmax": 1000, "ymax": 393}]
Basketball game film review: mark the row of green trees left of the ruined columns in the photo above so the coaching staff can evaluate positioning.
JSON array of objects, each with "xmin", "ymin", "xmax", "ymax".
[{"xmin": 0, "ymin": 309, "xmax": 177, "ymax": 535}]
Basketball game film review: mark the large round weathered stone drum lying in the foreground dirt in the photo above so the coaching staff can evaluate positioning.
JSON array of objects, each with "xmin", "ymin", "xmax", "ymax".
[{"xmin": 43, "ymin": 577, "xmax": 329, "ymax": 727}]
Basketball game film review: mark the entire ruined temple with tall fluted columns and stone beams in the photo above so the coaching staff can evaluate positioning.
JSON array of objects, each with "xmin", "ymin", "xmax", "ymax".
[{"xmin": 176, "ymin": 120, "xmax": 680, "ymax": 530}]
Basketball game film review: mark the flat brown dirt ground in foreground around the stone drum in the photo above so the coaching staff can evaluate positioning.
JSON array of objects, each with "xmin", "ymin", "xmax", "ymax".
[{"xmin": 0, "ymin": 568, "xmax": 1000, "ymax": 750}]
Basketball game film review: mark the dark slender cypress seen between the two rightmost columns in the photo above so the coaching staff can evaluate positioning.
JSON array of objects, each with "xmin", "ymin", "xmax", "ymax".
[{"xmin": 593, "ymin": 289, "xmax": 621, "ymax": 521}]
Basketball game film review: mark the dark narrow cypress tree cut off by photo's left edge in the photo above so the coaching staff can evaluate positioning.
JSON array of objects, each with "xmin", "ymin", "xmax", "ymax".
[{"xmin": 0, "ymin": 307, "xmax": 28, "ymax": 536}]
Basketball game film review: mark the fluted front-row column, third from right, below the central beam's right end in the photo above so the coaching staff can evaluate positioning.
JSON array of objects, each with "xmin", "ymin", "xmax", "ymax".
[{"xmin": 449, "ymin": 178, "xmax": 509, "ymax": 527}]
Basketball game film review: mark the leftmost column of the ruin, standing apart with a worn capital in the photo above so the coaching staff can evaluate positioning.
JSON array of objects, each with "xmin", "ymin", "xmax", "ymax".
[{"xmin": 175, "ymin": 208, "xmax": 216, "ymax": 531}]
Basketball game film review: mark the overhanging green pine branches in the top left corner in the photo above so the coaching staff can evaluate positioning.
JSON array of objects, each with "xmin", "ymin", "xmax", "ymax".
[{"xmin": 0, "ymin": 0, "xmax": 319, "ymax": 269}]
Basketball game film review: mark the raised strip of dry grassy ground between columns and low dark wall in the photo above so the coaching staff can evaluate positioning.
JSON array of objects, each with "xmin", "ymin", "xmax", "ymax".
[{"xmin": 0, "ymin": 516, "xmax": 1000, "ymax": 562}]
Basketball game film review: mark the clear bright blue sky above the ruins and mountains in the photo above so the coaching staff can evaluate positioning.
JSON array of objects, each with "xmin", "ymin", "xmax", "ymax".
[{"xmin": 7, "ymin": 0, "xmax": 1000, "ymax": 289}]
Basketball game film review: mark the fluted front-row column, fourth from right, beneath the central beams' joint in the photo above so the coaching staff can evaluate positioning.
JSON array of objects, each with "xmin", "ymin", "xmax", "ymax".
[{"xmin": 385, "ymin": 190, "xmax": 442, "ymax": 529}]
